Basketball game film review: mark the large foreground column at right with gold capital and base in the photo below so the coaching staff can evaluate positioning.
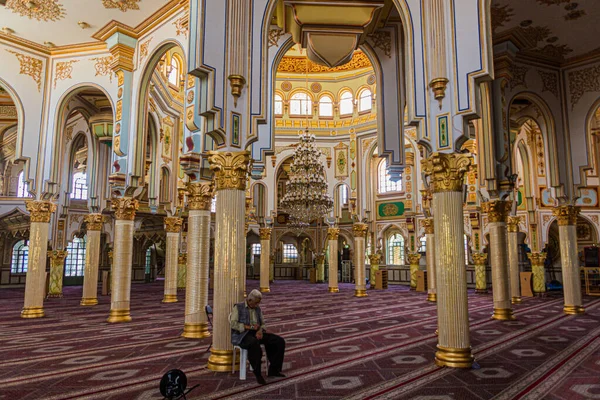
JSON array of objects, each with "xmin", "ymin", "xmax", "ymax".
[{"xmin": 422, "ymin": 153, "xmax": 474, "ymax": 368}]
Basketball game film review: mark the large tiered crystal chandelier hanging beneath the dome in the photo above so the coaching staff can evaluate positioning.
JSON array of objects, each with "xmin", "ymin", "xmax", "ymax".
[{"xmin": 281, "ymin": 129, "xmax": 333, "ymax": 228}]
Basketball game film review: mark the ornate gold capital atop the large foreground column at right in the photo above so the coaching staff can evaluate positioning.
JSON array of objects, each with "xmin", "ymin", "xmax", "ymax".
[{"xmin": 421, "ymin": 153, "xmax": 472, "ymax": 193}]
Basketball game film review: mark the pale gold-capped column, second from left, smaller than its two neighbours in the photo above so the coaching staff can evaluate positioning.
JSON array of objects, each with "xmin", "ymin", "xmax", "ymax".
[{"xmin": 79, "ymin": 214, "xmax": 104, "ymax": 306}]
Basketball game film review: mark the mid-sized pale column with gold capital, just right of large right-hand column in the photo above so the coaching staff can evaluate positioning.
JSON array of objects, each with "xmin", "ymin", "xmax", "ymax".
[{"xmin": 481, "ymin": 200, "xmax": 515, "ymax": 321}]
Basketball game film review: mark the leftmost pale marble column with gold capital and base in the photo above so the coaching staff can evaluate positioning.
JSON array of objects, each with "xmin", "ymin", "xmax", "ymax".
[{"xmin": 21, "ymin": 200, "xmax": 56, "ymax": 318}]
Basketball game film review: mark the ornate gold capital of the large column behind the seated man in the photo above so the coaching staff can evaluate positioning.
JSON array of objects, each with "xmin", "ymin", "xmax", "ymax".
[{"xmin": 208, "ymin": 150, "xmax": 250, "ymax": 190}]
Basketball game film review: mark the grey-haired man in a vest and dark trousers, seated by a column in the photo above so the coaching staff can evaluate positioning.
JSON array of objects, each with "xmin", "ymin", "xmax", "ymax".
[{"xmin": 229, "ymin": 289, "xmax": 285, "ymax": 385}]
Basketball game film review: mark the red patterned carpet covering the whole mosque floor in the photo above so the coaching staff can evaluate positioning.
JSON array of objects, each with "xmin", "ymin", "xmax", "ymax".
[{"xmin": 0, "ymin": 281, "xmax": 600, "ymax": 400}]
